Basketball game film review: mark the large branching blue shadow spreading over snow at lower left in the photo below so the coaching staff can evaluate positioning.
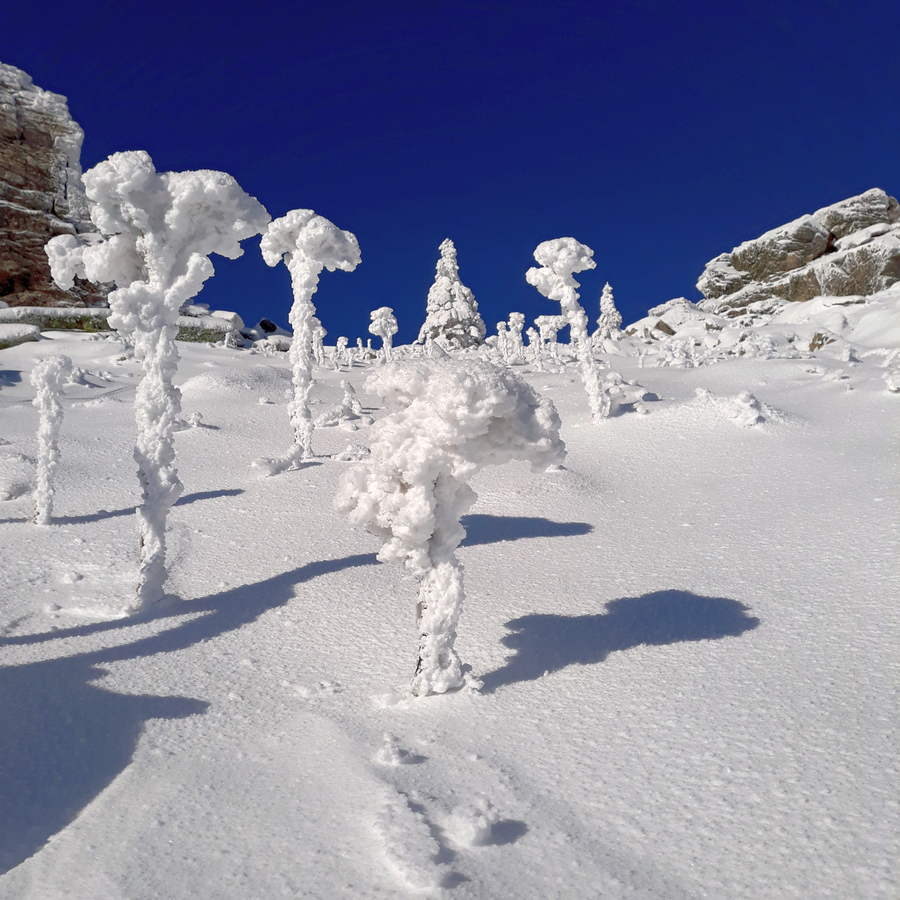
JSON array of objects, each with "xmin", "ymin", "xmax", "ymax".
[{"xmin": 0, "ymin": 553, "xmax": 376, "ymax": 875}]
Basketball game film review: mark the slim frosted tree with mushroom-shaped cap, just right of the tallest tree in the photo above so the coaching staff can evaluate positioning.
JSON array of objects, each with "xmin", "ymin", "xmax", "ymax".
[{"xmin": 257, "ymin": 209, "xmax": 360, "ymax": 475}]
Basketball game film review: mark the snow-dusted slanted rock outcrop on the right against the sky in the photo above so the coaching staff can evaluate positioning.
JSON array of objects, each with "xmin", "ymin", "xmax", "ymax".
[{"xmin": 697, "ymin": 188, "xmax": 900, "ymax": 317}]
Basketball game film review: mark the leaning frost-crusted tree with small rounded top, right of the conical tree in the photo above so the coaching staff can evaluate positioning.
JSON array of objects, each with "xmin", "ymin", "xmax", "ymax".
[{"xmin": 525, "ymin": 238, "xmax": 609, "ymax": 422}]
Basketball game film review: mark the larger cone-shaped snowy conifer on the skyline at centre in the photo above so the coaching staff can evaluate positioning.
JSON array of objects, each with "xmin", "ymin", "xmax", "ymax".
[{"xmin": 419, "ymin": 238, "xmax": 486, "ymax": 350}]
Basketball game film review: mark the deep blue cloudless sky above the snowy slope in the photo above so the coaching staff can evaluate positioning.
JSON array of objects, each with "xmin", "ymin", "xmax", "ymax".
[{"xmin": 0, "ymin": 0, "xmax": 900, "ymax": 343}]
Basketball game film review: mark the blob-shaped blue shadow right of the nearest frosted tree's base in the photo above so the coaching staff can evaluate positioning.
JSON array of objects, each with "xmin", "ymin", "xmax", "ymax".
[{"xmin": 482, "ymin": 591, "xmax": 759, "ymax": 694}]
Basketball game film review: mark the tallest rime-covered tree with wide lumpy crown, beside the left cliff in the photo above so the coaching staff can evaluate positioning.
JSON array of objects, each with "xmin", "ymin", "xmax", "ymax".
[{"xmin": 46, "ymin": 150, "xmax": 271, "ymax": 609}]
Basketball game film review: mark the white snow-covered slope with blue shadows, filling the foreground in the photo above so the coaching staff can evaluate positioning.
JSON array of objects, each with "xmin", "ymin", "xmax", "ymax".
[{"xmin": 0, "ymin": 332, "xmax": 900, "ymax": 900}]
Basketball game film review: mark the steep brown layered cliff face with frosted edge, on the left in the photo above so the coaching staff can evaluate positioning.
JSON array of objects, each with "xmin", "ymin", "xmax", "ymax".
[{"xmin": 0, "ymin": 63, "xmax": 106, "ymax": 306}]
